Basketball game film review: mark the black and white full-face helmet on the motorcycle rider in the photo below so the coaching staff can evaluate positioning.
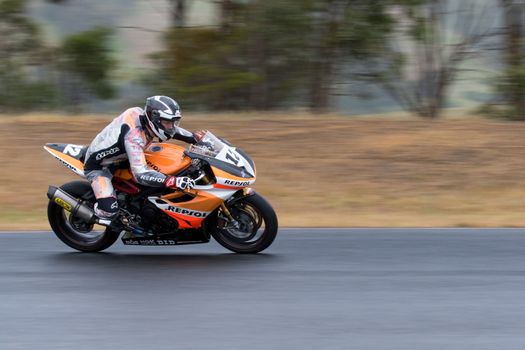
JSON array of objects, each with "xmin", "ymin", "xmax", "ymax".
[{"xmin": 144, "ymin": 96, "xmax": 182, "ymax": 141}]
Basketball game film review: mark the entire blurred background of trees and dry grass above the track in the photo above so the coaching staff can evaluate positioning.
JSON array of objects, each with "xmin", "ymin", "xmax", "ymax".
[{"xmin": 0, "ymin": 0, "xmax": 525, "ymax": 229}]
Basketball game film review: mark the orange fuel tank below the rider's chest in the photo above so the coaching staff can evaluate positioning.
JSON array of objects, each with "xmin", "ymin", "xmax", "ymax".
[{"xmin": 144, "ymin": 143, "xmax": 191, "ymax": 175}]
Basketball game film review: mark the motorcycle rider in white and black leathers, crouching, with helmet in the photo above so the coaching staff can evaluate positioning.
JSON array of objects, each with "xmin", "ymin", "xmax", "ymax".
[{"xmin": 84, "ymin": 96, "xmax": 202, "ymax": 225}]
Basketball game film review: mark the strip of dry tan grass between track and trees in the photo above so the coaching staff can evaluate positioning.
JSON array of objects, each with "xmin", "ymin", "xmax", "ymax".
[{"xmin": 0, "ymin": 113, "xmax": 525, "ymax": 230}]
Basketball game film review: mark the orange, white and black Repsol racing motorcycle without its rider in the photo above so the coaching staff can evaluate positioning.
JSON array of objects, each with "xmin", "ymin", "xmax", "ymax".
[{"xmin": 44, "ymin": 131, "xmax": 278, "ymax": 253}]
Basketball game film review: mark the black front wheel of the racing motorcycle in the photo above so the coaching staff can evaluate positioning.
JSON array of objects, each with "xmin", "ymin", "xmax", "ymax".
[{"xmin": 212, "ymin": 193, "xmax": 279, "ymax": 254}]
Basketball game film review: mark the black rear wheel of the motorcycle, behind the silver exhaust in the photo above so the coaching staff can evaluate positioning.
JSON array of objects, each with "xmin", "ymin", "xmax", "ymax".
[{"xmin": 47, "ymin": 181, "xmax": 120, "ymax": 252}]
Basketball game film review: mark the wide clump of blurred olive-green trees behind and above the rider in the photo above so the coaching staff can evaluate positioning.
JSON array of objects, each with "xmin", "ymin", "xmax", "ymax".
[{"xmin": 149, "ymin": 0, "xmax": 392, "ymax": 111}]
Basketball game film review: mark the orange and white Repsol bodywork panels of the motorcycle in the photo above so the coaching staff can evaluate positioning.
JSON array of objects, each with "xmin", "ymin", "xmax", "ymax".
[{"xmin": 44, "ymin": 132, "xmax": 255, "ymax": 229}]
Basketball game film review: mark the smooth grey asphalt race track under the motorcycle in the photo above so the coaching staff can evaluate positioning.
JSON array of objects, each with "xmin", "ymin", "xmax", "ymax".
[{"xmin": 0, "ymin": 229, "xmax": 525, "ymax": 350}]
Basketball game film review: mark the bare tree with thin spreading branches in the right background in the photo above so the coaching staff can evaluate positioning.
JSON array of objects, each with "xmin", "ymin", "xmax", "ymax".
[{"xmin": 370, "ymin": 0, "xmax": 496, "ymax": 119}]
